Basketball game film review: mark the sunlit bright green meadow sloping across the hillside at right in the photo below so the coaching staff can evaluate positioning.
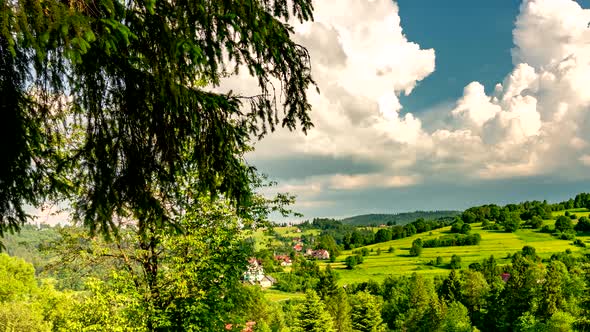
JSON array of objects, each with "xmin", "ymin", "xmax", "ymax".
[{"xmin": 322, "ymin": 209, "xmax": 590, "ymax": 284}]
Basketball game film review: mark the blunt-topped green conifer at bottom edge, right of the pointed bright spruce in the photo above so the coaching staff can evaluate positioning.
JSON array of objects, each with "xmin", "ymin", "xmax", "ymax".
[{"xmin": 351, "ymin": 291, "xmax": 385, "ymax": 332}]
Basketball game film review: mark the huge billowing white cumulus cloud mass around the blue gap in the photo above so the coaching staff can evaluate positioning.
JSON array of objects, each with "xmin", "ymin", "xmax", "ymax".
[{"xmin": 244, "ymin": 0, "xmax": 590, "ymax": 217}]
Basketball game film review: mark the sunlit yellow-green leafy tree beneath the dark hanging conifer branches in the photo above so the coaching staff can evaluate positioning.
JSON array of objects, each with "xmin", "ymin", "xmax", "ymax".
[{"xmin": 49, "ymin": 198, "xmax": 276, "ymax": 331}]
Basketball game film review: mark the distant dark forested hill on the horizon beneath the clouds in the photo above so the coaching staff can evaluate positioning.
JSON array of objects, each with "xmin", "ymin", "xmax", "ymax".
[{"xmin": 342, "ymin": 211, "xmax": 461, "ymax": 226}]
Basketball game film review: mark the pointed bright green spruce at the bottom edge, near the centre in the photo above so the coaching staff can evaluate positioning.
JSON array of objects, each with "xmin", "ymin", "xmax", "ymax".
[{"xmin": 294, "ymin": 291, "xmax": 334, "ymax": 332}]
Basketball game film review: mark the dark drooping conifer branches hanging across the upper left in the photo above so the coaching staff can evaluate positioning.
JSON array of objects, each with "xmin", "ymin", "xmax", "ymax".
[{"xmin": 0, "ymin": 0, "xmax": 314, "ymax": 246}]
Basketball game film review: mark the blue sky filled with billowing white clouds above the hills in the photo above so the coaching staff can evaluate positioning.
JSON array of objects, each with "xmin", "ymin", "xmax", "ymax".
[{"xmin": 235, "ymin": 0, "xmax": 590, "ymax": 223}]
